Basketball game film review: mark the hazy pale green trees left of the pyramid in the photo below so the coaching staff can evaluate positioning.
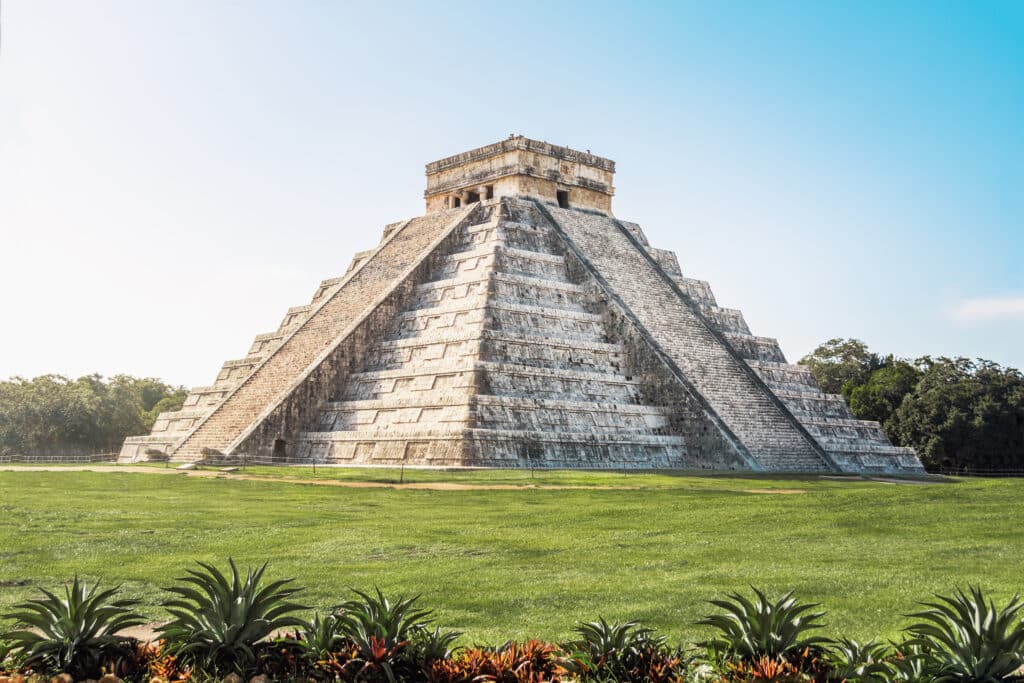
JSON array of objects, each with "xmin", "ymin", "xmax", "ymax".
[{"xmin": 0, "ymin": 375, "xmax": 188, "ymax": 456}]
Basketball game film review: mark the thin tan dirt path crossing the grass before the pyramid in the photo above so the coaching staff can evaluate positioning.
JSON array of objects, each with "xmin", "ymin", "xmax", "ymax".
[{"xmin": 0, "ymin": 465, "xmax": 640, "ymax": 490}]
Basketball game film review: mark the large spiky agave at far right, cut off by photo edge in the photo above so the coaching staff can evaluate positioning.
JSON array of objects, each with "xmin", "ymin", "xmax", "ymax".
[{"xmin": 906, "ymin": 587, "xmax": 1024, "ymax": 683}]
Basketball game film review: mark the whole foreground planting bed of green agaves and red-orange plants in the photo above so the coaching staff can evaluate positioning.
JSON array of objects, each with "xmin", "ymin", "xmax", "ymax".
[{"xmin": 0, "ymin": 559, "xmax": 1024, "ymax": 683}]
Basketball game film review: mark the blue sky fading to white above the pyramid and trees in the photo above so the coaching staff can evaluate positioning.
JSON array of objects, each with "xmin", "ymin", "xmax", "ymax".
[{"xmin": 0, "ymin": 0, "xmax": 1024, "ymax": 385}]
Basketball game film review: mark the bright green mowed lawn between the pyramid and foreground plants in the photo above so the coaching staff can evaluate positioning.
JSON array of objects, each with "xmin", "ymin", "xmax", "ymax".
[{"xmin": 0, "ymin": 468, "xmax": 1024, "ymax": 643}]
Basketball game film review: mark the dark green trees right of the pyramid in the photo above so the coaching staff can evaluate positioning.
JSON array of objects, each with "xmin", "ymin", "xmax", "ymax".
[{"xmin": 800, "ymin": 339, "xmax": 1024, "ymax": 473}]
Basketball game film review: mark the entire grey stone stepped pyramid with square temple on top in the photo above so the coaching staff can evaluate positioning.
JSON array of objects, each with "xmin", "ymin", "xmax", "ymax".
[{"xmin": 121, "ymin": 136, "xmax": 924, "ymax": 473}]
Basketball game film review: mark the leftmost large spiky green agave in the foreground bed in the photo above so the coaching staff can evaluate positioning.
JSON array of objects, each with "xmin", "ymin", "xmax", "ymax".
[{"xmin": 5, "ymin": 577, "xmax": 143, "ymax": 679}]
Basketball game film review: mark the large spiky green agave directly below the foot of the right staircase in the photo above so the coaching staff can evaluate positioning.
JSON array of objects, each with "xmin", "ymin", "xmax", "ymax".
[{"xmin": 697, "ymin": 586, "xmax": 830, "ymax": 659}]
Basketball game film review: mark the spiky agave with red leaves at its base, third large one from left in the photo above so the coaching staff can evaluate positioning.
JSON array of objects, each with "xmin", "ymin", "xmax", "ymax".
[{"xmin": 337, "ymin": 589, "xmax": 430, "ymax": 683}]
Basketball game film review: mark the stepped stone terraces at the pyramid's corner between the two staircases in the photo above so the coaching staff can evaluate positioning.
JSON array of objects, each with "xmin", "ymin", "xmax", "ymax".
[{"xmin": 290, "ymin": 201, "xmax": 686, "ymax": 468}]
